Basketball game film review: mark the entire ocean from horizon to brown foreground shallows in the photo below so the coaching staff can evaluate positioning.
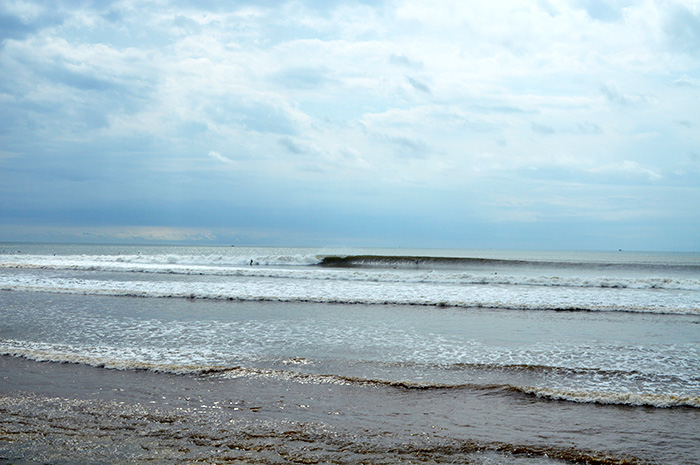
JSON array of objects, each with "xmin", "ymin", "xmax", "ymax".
[{"xmin": 0, "ymin": 243, "xmax": 700, "ymax": 465}]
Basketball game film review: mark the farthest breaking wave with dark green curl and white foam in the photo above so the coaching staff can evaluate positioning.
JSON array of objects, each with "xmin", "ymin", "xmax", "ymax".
[{"xmin": 0, "ymin": 254, "xmax": 700, "ymax": 291}]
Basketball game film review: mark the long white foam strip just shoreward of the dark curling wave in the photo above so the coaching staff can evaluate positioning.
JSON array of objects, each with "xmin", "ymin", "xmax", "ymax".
[{"xmin": 0, "ymin": 274, "xmax": 700, "ymax": 315}]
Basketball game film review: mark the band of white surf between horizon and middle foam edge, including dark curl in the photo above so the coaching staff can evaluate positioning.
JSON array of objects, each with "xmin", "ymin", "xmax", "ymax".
[{"xmin": 0, "ymin": 247, "xmax": 700, "ymax": 314}]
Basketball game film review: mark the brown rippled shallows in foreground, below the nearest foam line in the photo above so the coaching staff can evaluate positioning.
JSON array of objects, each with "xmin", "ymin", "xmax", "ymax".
[{"xmin": 0, "ymin": 356, "xmax": 691, "ymax": 465}]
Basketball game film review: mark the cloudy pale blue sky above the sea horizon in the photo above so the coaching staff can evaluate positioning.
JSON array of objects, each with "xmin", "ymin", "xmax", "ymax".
[{"xmin": 0, "ymin": 0, "xmax": 700, "ymax": 251}]
